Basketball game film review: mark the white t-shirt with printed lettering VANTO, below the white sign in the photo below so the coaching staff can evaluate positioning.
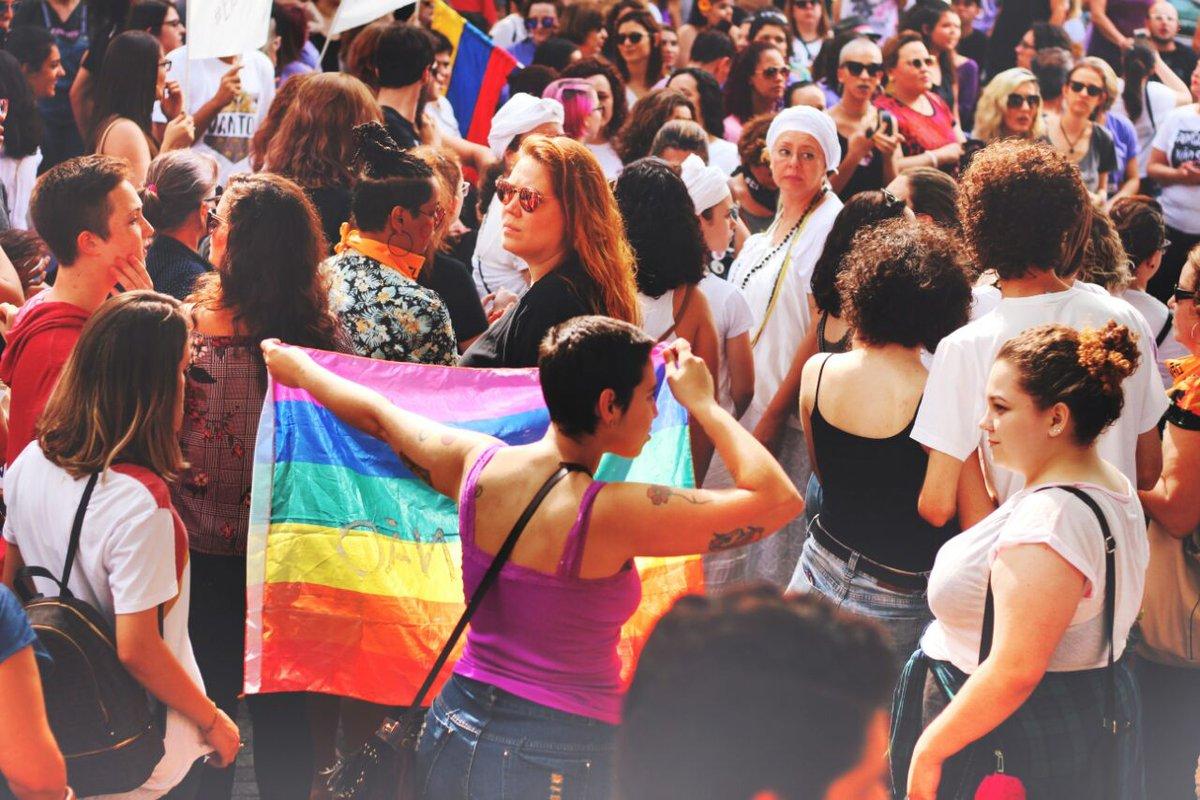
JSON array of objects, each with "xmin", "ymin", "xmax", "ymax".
[{"xmin": 155, "ymin": 44, "xmax": 275, "ymax": 186}]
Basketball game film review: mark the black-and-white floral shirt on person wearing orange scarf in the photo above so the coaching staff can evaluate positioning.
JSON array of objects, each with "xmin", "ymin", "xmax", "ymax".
[{"xmin": 325, "ymin": 249, "xmax": 458, "ymax": 366}]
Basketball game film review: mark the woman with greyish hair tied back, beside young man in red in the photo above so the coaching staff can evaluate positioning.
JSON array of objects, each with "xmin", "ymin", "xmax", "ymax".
[{"xmin": 142, "ymin": 149, "xmax": 221, "ymax": 300}]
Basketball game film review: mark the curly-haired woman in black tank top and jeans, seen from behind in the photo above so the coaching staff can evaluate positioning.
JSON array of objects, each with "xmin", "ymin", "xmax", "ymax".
[{"xmin": 790, "ymin": 217, "xmax": 971, "ymax": 670}]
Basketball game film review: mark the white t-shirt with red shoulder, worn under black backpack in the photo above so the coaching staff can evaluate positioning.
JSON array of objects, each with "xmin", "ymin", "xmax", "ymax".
[{"xmin": 4, "ymin": 448, "xmax": 211, "ymax": 800}]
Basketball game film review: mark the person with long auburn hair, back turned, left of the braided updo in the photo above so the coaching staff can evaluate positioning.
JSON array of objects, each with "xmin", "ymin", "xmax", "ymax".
[{"xmin": 265, "ymin": 72, "xmax": 383, "ymax": 248}]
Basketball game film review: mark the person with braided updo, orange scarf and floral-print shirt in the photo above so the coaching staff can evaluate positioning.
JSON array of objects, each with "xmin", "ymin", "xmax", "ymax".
[{"xmin": 325, "ymin": 122, "xmax": 458, "ymax": 365}]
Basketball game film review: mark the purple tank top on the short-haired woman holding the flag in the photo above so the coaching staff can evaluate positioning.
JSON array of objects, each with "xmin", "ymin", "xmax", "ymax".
[{"xmin": 455, "ymin": 445, "xmax": 642, "ymax": 724}]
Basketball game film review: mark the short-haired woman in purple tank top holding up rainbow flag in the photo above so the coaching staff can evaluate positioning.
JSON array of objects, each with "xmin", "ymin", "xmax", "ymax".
[{"xmin": 263, "ymin": 317, "xmax": 804, "ymax": 800}]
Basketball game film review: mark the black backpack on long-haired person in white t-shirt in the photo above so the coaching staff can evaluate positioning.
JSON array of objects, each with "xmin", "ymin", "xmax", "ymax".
[{"xmin": 17, "ymin": 475, "xmax": 166, "ymax": 798}]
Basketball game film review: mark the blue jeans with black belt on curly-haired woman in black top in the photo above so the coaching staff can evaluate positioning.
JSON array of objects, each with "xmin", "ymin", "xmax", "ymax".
[{"xmin": 787, "ymin": 525, "xmax": 934, "ymax": 675}]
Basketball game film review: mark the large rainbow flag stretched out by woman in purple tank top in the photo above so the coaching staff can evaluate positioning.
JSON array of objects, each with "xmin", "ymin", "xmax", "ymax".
[{"xmin": 245, "ymin": 350, "xmax": 703, "ymax": 705}]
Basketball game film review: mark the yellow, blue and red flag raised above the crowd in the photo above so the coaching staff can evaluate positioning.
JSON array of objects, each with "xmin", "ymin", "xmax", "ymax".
[{"xmin": 433, "ymin": 0, "xmax": 520, "ymax": 146}]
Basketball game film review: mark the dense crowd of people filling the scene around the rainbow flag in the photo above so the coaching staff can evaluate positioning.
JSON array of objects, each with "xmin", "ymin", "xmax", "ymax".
[{"xmin": 0, "ymin": 0, "xmax": 1200, "ymax": 800}]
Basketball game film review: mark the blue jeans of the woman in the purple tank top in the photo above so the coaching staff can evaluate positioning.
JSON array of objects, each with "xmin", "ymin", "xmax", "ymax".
[{"xmin": 416, "ymin": 675, "xmax": 617, "ymax": 800}]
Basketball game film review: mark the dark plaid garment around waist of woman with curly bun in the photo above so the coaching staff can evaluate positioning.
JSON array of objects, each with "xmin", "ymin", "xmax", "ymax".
[{"xmin": 890, "ymin": 649, "xmax": 1146, "ymax": 800}]
